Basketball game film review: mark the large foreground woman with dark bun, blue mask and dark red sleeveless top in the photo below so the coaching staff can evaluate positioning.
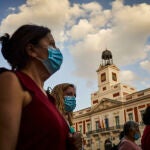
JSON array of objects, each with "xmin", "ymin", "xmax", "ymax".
[{"xmin": 0, "ymin": 25, "xmax": 75, "ymax": 150}]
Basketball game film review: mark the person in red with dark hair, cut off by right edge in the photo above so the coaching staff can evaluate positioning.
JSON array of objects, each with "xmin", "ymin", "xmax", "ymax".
[{"xmin": 141, "ymin": 106, "xmax": 150, "ymax": 150}]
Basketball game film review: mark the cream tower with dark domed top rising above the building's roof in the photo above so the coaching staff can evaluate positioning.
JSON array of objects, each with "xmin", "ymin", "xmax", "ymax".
[{"xmin": 91, "ymin": 49, "xmax": 136, "ymax": 107}]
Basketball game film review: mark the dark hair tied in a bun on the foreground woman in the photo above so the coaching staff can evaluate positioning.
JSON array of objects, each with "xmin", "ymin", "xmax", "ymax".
[{"xmin": 0, "ymin": 25, "xmax": 50, "ymax": 70}]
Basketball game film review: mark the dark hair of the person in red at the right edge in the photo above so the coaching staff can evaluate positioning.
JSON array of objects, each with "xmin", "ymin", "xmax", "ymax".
[{"xmin": 142, "ymin": 106, "xmax": 150, "ymax": 125}]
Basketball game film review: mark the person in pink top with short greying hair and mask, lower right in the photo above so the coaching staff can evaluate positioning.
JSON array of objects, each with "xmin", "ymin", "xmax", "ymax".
[{"xmin": 118, "ymin": 121, "xmax": 141, "ymax": 150}]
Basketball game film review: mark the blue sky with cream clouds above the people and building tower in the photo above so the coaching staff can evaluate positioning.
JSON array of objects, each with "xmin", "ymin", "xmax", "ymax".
[{"xmin": 0, "ymin": 0, "xmax": 150, "ymax": 110}]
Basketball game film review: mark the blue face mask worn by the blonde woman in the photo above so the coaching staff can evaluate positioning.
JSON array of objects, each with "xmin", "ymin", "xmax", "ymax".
[{"xmin": 64, "ymin": 96, "xmax": 76, "ymax": 112}]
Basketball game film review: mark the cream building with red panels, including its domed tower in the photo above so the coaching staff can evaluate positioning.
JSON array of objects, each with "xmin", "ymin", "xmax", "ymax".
[{"xmin": 74, "ymin": 50, "xmax": 150, "ymax": 150}]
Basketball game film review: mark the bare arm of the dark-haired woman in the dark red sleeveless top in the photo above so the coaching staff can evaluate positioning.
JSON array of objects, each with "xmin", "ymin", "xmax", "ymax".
[{"xmin": 0, "ymin": 72, "xmax": 23, "ymax": 150}]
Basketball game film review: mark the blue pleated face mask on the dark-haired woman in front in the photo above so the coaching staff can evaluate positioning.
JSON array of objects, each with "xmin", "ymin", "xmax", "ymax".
[{"xmin": 41, "ymin": 47, "xmax": 63, "ymax": 74}]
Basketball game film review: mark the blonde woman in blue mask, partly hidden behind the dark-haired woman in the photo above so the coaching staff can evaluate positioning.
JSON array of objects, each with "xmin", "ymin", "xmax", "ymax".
[{"xmin": 50, "ymin": 83, "xmax": 82, "ymax": 150}]
